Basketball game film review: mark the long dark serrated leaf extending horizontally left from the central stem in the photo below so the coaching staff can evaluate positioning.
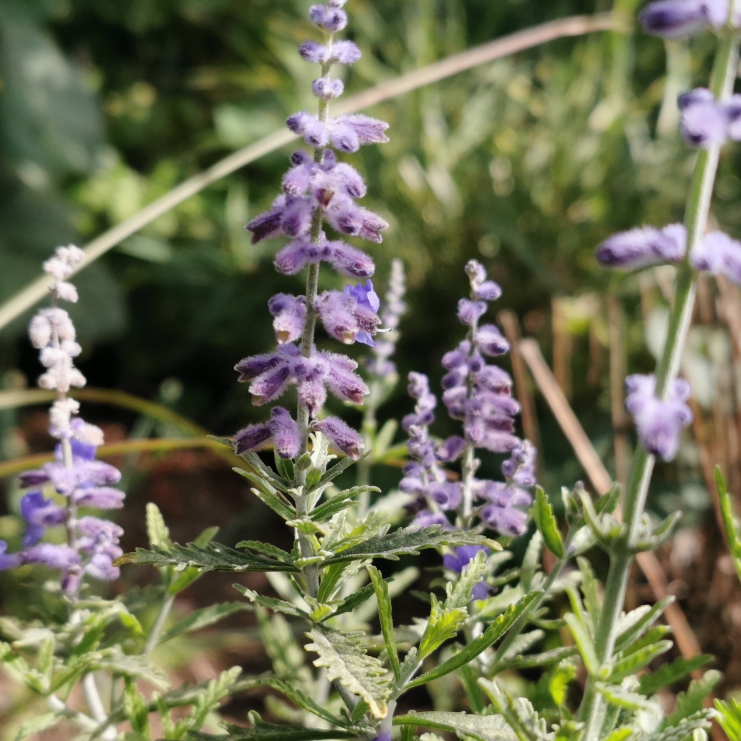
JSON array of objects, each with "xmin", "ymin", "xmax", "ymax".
[{"xmin": 115, "ymin": 543, "xmax": 299, "ymax": 572}]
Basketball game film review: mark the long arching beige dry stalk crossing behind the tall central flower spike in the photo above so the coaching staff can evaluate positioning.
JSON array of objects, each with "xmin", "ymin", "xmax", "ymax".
[{"xmin": 0, "ymin": 13, "xmax": 623, "ymax": 329}]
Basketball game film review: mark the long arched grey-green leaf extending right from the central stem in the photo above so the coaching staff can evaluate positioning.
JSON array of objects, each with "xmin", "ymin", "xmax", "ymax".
[{"xmin": 325, "ymin": 525, "xmax": 501, "ymax": 566}]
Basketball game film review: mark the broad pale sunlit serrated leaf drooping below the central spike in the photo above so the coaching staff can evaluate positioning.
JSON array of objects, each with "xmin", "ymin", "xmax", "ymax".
[{"xmin": 306, "ymin": 627, "xmax": 391, "ymax": 718}]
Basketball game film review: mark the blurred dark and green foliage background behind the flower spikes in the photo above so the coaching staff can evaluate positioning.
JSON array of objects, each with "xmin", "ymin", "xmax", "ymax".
[{"xmin": 0, "ymin": 0, "xmax": 741, "ymax": 692}]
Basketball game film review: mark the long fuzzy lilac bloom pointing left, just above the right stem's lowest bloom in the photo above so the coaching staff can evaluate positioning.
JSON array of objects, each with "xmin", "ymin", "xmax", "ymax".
[{"xmin": 596, "ymin": 224, "xmax": 687, "ymax": 270}]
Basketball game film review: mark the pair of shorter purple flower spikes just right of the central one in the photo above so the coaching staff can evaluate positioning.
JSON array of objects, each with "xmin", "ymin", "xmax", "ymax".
[{"xmin": 400, "ymin": 260, "xmax": 536, "ymax": 599}]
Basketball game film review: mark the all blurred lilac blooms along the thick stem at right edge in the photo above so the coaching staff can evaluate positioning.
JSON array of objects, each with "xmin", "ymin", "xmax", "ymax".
[{"xmin": 596, "ymin": 0, "xmax": 741, "ymax": 461}]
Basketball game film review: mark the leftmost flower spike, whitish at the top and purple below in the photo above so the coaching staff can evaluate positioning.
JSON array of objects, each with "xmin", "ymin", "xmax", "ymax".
[{"xmin": 0, "ymin": 245, "xmax": 124, "ymax": 598}]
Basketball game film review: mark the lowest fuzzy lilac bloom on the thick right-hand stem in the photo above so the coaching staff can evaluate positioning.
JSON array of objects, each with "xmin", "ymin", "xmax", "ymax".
[{"xmin": 625, "ymin": 375, "xmax": 692, "ymax": 461}]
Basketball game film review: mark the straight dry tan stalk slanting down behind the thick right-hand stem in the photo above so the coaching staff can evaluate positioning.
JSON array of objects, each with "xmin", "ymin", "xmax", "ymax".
[{"xmin": 520, "ymin": 339, "xmax": 702, "ymax": 659}]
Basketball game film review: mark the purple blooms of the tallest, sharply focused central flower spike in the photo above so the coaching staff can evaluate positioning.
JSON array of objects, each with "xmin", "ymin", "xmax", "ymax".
[{"xmin": 235, "ymin": 0, "xmax": 388, "ymax": 458}]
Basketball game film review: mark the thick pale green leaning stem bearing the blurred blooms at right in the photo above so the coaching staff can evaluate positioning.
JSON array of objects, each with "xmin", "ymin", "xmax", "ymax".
[{"xmin": 579, "ymin": 18, "xmax": 738, "ymax": 741}]
